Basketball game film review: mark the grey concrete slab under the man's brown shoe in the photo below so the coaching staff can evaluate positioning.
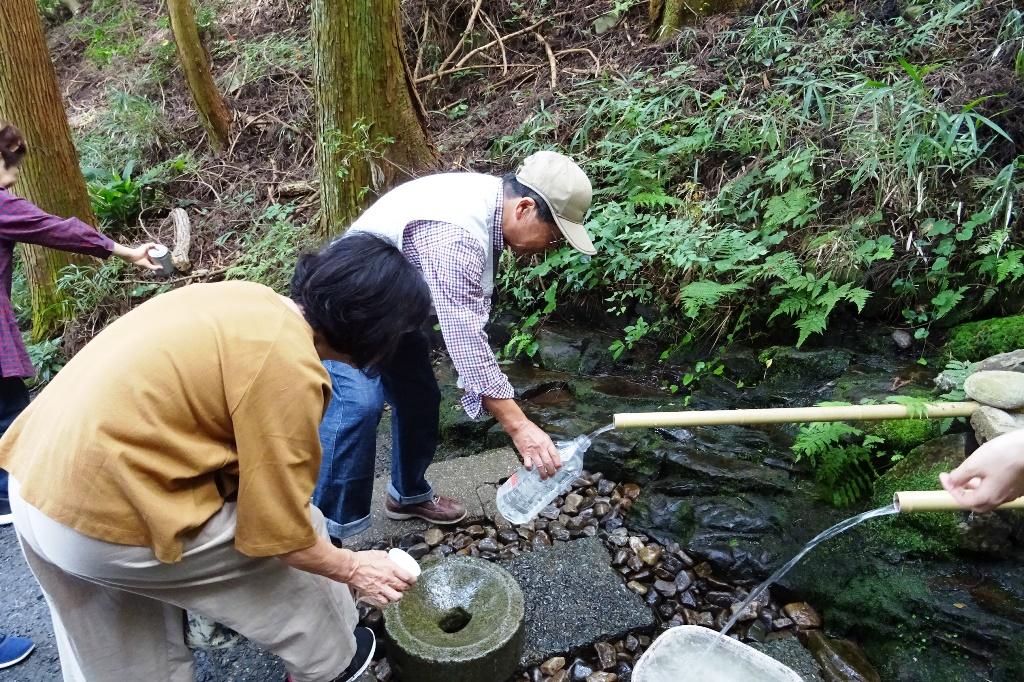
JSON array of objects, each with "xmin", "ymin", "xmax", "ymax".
[{"xmin": 345, "ymin": 447, "xmax": 519, "ymax": 549}]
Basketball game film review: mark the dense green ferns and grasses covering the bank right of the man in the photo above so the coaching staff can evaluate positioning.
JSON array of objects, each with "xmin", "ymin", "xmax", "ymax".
[{"xmin": 492, "ymin": 0, "xmax": 1024, "ymax": 355}]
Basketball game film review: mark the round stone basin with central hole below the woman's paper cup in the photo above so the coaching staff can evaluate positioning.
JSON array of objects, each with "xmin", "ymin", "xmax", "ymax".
[{"xmin": 384, "ymin": 557, "xmax": 524, "ymax": 682}]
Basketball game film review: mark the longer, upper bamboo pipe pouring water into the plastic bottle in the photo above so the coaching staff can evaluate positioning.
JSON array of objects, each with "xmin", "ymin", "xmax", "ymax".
[{"xmin": 613, "ymin": 401, "xmax": 979, "ymax": 429}]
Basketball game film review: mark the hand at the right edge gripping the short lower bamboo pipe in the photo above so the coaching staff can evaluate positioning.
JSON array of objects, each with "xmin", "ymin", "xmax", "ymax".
[{"xmin": 939, "ymin": 429, "xmax": 1024, "ymax": 512}]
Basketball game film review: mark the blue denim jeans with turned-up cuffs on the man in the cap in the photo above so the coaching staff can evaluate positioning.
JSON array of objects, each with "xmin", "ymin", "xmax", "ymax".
[{"xmin": 313, "ymin": 332, "xmax": 440, "ymax": 539}]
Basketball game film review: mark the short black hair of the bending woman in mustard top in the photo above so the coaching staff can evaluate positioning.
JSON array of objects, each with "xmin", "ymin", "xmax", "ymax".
[{"xmin": 291, "ymin": 232, "xmax": 430, "ymax": 371}]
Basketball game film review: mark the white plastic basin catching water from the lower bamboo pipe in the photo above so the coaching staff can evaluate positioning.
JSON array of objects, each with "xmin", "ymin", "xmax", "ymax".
[{"xmin": 633, "ymin": 626, "xmax": 802, "ymax": 682}]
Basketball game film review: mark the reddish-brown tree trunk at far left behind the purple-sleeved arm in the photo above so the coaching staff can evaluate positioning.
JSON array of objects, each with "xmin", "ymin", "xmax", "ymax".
[{"xmin": 0, "ymin": 0, "xmax": 96, "ymax": 341}]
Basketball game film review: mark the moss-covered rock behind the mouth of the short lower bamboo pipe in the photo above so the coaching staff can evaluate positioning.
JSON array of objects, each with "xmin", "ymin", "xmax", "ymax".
[{"xmin": 870, "ymin": 432, "xmax": 965, "ymax": 557}]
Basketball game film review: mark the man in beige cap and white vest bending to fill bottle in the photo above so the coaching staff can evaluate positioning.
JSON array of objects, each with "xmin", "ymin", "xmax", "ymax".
[{"xmin": 313, "ymin": 152, "xmax": 596, "ymax": 540}]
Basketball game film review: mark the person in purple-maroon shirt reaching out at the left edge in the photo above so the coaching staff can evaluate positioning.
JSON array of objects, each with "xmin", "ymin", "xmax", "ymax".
[{"xmin": 0, "ymin": 121, "xmax": 160, "ymax": 669}]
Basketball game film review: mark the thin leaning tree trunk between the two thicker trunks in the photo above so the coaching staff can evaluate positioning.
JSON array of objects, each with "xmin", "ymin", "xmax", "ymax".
[{"xmin": 167, "ymin": 0, "xmax": 231, "ymax": 152}]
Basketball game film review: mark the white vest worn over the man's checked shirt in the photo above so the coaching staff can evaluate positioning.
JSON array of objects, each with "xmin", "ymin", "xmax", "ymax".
[{"xmin": 349, "ymin": 173, "xmax": 502, "ymax": 297}]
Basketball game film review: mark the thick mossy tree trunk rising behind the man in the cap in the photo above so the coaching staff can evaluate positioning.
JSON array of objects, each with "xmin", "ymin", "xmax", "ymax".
[{"xmin": 312, "ymin": 0, "xmax": 437, "ymax": 235}]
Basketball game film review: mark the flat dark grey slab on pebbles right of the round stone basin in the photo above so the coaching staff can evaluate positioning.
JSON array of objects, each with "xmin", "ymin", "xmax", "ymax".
[{"xmin": 502, "ymin": 538, "xmax": 655, "ymax": 666}]
